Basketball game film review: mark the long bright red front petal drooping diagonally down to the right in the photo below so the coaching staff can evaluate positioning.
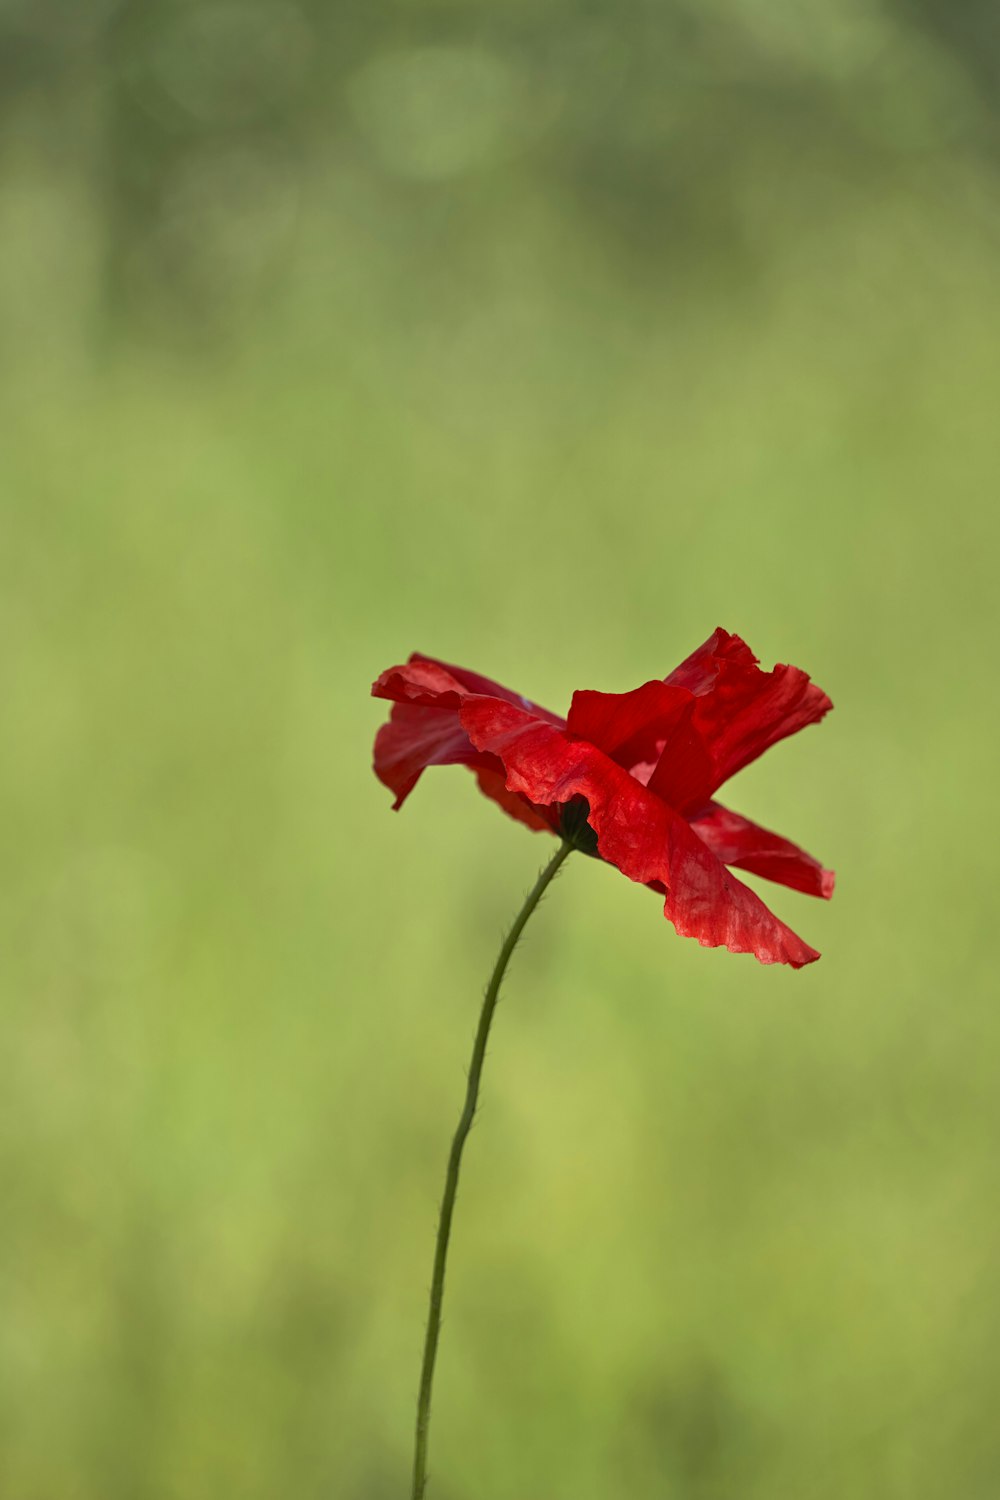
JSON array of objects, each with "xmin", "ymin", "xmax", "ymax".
[{"xmin": 462, "ymin": 696, "xmax": 819, "ymax": 969}]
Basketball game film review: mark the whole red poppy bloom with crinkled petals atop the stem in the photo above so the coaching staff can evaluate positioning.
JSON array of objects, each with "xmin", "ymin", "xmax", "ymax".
[{"xmin": 372, "ymin": 630, "xmax": 834, "ymax": 969}]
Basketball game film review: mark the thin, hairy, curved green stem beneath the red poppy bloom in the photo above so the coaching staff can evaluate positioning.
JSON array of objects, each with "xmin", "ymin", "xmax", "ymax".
[{"xmin": 412, "ymin": 843, "xmax": 573, "ymax": 1500}]
